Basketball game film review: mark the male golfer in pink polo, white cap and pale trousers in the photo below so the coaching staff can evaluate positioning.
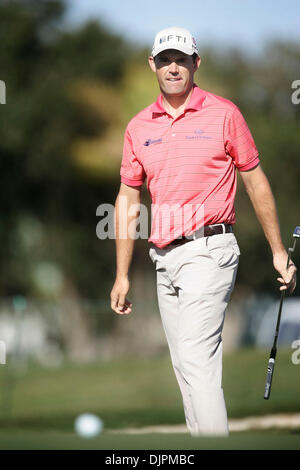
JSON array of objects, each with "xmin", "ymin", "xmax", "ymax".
[{"xmin": 111, "ymin": 28, "xmax": 296, "ymax": 435}]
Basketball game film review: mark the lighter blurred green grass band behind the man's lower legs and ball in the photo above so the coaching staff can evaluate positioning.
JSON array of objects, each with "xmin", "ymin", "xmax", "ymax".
[{"xmin": 0, "ymin": 349, "xmax": 300, "ymax": 439}]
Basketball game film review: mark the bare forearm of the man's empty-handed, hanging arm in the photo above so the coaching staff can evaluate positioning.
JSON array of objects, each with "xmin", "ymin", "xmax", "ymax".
[{"xmin": 115, "ymin": 196, "xmax": 139, "ymax": 277}]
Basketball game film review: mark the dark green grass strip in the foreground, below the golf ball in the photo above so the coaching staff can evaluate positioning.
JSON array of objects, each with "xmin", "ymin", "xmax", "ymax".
[{"xmin": 0, "ymin": 430, "xmax": 300, "ymax": 456}]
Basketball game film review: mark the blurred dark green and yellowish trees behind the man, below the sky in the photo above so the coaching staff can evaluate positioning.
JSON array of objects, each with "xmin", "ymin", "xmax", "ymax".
[{"xmin": 0, "ymin": 0, "xmax": 300, "ymax": 300}]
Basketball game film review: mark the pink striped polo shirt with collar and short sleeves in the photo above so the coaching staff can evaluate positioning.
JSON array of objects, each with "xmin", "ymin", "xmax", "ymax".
[{"xmin": 120, "ymin": 85, "xmax": 259, "ymax": 248}]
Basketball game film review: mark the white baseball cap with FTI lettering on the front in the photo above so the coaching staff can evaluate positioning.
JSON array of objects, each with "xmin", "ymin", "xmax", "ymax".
[{"xmin": 151, "ymin": 26, "xmax": 199, "ymax": 57}]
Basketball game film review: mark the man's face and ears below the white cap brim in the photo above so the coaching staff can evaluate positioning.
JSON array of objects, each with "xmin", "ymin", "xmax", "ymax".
[{"xmin": 149, "ymin": 49, "xmax": 200, "ymax": 96}]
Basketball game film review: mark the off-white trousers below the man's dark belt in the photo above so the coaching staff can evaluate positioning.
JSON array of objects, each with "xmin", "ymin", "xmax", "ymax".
[{"xmin": 149, "ymin": 233, "xmax": 240, "ymax": 436}]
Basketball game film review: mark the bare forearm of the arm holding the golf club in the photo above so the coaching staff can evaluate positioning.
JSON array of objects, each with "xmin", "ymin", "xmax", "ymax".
[{"xmin": 247, "ymin": 177, "xmax": 285, "ymax": 255}]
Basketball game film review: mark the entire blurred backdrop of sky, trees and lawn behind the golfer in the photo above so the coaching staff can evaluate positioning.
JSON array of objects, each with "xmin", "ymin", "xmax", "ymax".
[{"xmin": 0, "ymin": 0, "xmax": 300, "ymax": 438}]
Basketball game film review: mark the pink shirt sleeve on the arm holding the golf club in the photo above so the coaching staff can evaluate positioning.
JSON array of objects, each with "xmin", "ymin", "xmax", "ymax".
[{"xmin": 224, "ymin": 106, "xmax": 259, "ymax": 171}]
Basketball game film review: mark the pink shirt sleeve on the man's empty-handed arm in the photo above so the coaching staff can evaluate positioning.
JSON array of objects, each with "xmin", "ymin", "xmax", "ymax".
[{"xmin": 120, "ymin": 127, "xmax": 146, "ymax": 186}]
